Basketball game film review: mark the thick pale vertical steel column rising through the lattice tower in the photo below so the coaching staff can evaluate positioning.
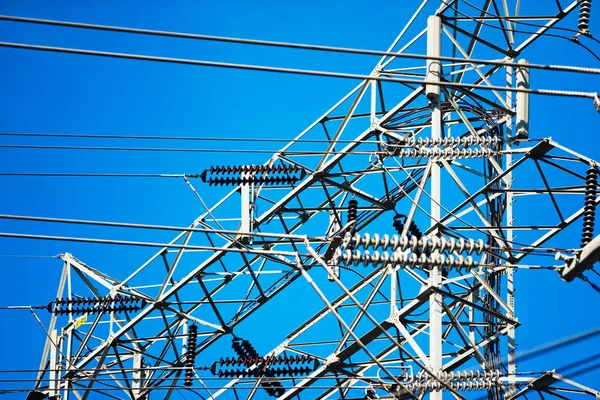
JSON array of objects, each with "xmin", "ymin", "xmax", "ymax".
[{"xmin": 425, "ymin": 16, "xmax": 443, "ymax": 400}]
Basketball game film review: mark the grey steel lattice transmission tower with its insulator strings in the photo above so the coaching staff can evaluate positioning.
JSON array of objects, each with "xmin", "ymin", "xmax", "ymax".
[{"xmin": 14, "ymin": 0, "xmax": 600, "ymax": 400}]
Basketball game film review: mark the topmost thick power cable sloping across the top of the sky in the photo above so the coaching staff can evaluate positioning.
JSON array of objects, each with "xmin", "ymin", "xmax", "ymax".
[{"xmin": 0, "ymin": 15, "xmax": 600, "ymax": 74}]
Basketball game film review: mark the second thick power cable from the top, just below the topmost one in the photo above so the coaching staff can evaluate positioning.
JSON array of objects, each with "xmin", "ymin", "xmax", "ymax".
[{"xmin": 0, "ymin": 42, "xmax": 600, "ymax": 102}]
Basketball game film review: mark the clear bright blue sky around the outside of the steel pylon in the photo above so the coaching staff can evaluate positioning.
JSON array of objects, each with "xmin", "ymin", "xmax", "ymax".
[{"xmin": 0, "ymin": 0, "xmax": 600, "ymax": 398}]
